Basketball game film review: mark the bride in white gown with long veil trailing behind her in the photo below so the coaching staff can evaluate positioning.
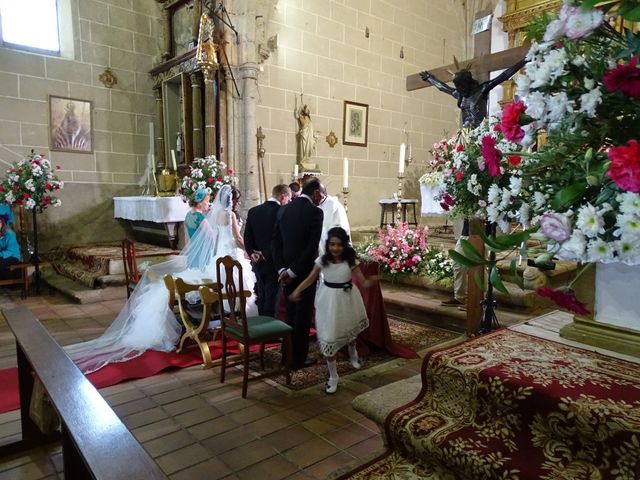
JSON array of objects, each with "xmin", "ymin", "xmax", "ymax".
[{"xmin": 65, "ymin": 185, "xmax": 257, "ymax": 374}]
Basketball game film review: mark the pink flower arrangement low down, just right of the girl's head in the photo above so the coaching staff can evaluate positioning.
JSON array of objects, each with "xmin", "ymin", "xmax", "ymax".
[{"xmin": 367, "ymin": 222, "xmax": 429, "ymax": 275}]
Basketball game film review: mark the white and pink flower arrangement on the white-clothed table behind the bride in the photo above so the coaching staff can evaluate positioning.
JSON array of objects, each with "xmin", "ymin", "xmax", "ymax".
[{"xmin": 178, "ymin": 155, "xmax": 236, "ymax": 202}]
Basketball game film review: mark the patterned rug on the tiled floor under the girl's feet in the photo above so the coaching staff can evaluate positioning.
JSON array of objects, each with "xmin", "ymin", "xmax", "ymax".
[{"xmin": 251, "ymin": 318, "xmax": 459, "ymax": 390}]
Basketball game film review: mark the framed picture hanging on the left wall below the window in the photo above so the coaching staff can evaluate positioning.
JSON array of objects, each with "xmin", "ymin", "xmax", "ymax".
[{"xmin": 49, "ymin": 95, "xmax": 93, "ymax": 153}]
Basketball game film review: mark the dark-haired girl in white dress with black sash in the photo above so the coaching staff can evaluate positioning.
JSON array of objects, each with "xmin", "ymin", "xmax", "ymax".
[{"xmin": 289, "ymin": 227, "xmax": 375, "ymax": 393}]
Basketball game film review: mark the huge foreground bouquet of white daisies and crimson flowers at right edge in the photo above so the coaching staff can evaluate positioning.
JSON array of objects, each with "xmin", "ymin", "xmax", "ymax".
[{"xmin": 500, "ymin": 1, "xmax": 640, "ymax": 265}]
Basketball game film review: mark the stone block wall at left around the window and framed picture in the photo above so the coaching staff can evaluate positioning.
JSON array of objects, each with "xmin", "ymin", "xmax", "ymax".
[{"xmin": 0, "ymin": 0, "xmax": 161, "ymax": 248}]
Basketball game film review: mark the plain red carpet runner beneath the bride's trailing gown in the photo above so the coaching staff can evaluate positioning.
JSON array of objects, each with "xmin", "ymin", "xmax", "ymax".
[{"xmin": 0, "ymin": 342, "xmax": 238, "ymax": 413}]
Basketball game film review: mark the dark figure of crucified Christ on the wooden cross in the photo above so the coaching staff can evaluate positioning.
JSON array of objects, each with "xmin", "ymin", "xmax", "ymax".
[{"xmin": 420, "ymin": 57, "xmax": 527, "ymax": 128}]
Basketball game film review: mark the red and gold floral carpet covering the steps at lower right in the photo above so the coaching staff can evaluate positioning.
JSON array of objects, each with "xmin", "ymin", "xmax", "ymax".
[{"xmin": 340, "ymin": 329, "xmax": 640, "ymax": 480}]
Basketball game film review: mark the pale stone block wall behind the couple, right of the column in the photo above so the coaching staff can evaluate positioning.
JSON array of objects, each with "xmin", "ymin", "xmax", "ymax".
[{"xmin": 257, "ymin": 0, "xmax": 467, "ymax": 227}]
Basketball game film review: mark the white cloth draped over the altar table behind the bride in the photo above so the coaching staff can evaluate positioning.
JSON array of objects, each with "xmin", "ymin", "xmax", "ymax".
[{"xmin": 113, "ymin": 196, "xmax": 189, "ymax": 223}]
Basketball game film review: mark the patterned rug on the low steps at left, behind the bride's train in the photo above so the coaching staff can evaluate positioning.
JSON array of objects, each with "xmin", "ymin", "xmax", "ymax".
[{"xmin": 47, "ymin": 243, "xmax": 175, "ymax": 288}]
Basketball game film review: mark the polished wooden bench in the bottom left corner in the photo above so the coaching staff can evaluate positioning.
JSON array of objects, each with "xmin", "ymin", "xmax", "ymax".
[{"xmin": 0, "ymin": 306, "xmax": 167, "ymax": 480}]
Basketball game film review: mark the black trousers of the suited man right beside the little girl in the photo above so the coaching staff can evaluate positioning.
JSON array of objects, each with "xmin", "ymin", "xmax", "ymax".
[{"xmin": 284, "ymin": 275, "xmax": 316, "ymax": 368}]
